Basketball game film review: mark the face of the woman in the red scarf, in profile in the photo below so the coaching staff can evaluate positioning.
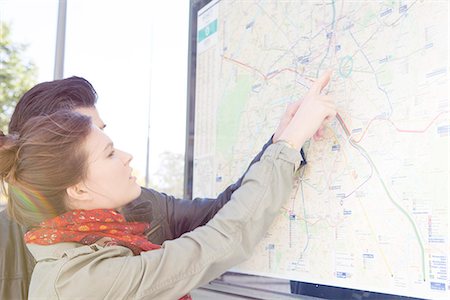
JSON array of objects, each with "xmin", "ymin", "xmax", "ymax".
[{"xmin": 75, "ymin": 126, "xmax": 141, "ymax": 209}]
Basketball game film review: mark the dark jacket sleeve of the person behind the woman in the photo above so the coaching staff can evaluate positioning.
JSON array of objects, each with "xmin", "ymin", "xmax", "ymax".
[{"xmin": 122, "ymin": 136, "xmax": 306, "ymax": 244}]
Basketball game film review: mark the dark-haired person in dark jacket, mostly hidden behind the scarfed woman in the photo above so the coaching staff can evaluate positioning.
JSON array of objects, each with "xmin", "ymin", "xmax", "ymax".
[{"xmin": 0, "ymin": 76, "xmax": 286, "ymax": 299}]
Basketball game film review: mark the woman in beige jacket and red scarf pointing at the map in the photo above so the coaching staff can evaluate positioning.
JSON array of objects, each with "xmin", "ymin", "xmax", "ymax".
[{"xmin": 0, "ymin": 73, "xmax": 335, "ymax": 299}]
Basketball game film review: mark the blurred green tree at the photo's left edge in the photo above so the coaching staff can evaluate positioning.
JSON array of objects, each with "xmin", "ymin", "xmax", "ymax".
[{"xmin": 0, "ymin": 22, "xmax": 37, "ymax": 132}]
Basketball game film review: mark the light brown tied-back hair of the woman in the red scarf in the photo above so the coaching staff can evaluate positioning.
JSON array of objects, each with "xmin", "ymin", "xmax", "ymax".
[{"xmin": 0, "ymin": 110, "xmax": 92, "ymax": 227}]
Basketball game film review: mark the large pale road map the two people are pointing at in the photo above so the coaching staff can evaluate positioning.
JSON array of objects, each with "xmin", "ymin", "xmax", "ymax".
[{"xmin": 193, "ymin": 0, "xmax": 450, "ymax": 299}]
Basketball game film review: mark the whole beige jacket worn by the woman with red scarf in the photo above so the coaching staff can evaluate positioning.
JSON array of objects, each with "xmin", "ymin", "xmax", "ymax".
[{"xmin": 27, "ymin": 144, "xmax": 301, "ymax": 299}]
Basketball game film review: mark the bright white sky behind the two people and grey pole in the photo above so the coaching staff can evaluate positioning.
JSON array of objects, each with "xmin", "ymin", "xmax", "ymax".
[{"xmin": 0, "ymin": 0, "xmax": 189, "ymax": 184}]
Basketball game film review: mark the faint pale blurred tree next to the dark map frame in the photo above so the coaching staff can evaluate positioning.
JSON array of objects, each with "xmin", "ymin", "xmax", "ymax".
[{"xmin": 150, "ymin": 151, "xmax": 184, "ymax": 198}]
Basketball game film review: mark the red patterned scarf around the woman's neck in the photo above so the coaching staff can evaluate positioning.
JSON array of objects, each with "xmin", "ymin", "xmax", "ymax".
[{"xmin": 24, "ymin": 209, "xmax": 192, "ymax": 300}]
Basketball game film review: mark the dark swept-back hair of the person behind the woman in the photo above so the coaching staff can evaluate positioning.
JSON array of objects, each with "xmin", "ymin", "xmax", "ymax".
[{"xmin": 8, "ymin": 76, "xmax": 97, "ymax": 133}]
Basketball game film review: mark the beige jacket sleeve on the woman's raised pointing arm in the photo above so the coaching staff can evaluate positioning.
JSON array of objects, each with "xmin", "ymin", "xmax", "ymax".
[{"xmin": 103, "ymin": 144, "xmax": 301, "ymax": 299}]
